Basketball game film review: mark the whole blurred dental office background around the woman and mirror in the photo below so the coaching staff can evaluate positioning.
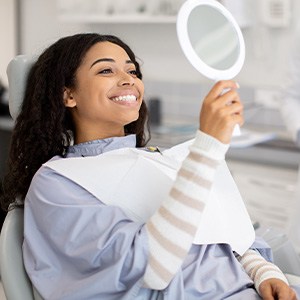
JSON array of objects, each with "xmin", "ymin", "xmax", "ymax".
[{"xmin": 0, "ymin": 0, "xmax": 300, "ymax": 253}]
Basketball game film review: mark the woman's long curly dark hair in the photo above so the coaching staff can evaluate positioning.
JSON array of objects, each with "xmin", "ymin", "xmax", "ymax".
[{"xmin": 1, "ymin": 33, "xmax": 150, "ymax": 210}]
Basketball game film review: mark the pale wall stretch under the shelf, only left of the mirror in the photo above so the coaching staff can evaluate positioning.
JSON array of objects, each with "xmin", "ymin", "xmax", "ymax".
[{"xmin": 21, "ymin": 0, "xmax": 201, "ymax": 84}]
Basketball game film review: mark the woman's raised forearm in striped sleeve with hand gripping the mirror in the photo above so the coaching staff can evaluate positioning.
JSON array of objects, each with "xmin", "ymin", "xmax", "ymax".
[{"xmin": 144, "ymin": 81, "xmax": 243, "ymax": 289}]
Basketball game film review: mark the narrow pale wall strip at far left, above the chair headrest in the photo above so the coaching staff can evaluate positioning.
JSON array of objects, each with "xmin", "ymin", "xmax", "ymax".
[{"xmin": 0, "ymin": 0, "xmax": 16, "ymax": 85}]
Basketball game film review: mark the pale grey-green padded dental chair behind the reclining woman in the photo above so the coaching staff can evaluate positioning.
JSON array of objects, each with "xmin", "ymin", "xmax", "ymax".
[{"xmin": 0, "ymin": 55, "xmax": 300, "ymax": 300}]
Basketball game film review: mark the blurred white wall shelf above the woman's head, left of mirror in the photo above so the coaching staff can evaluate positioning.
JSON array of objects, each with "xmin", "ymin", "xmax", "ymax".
[{"xmin": 56, "ymin": 0, "xmax": 185, "ymax": 23}]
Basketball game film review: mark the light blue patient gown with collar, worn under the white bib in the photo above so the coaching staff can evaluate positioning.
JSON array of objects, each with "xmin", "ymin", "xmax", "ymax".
[{"xmin": 23, "ymin": 135, "xmax": 300, "ymax": 300}]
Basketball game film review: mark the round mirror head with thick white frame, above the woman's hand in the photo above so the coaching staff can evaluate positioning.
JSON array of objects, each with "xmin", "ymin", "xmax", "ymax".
[{"xmin": 177, "ymin": 0, "xmax": 245, "ymax": 80}]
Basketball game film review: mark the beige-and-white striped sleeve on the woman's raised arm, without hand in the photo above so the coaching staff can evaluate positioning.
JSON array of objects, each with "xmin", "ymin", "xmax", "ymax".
[{"xmin": 144, "ymin": 131, "xmax": 228, "ymax": 290}]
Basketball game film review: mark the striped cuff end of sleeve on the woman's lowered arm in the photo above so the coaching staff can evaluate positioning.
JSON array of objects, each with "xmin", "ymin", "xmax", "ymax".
[{"xmin": 237, "ymin": 249, "xmax": 289, "ymax": 293}]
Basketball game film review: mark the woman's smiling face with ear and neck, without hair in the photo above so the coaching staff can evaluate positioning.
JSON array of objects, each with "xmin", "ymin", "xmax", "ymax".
[{"xmin": 64, "ymin": 42, "xmax": 144, "ymax": 143}]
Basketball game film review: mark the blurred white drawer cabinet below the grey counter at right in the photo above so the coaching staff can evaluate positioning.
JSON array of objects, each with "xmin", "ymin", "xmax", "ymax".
[{"xmin": 228, "ymin": 160, "xmax": 299, "ymax": 233}]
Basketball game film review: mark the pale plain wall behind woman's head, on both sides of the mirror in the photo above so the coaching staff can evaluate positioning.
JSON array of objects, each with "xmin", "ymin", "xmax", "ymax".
[{"xmin": 17, "ymin": 0, "xmax": 300, "ymax": 87}]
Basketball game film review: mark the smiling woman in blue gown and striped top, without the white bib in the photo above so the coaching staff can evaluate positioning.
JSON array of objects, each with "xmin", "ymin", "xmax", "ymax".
[{"xmin": 2, "ymin": 34, "xmax": 296, "ymax": 300}]
